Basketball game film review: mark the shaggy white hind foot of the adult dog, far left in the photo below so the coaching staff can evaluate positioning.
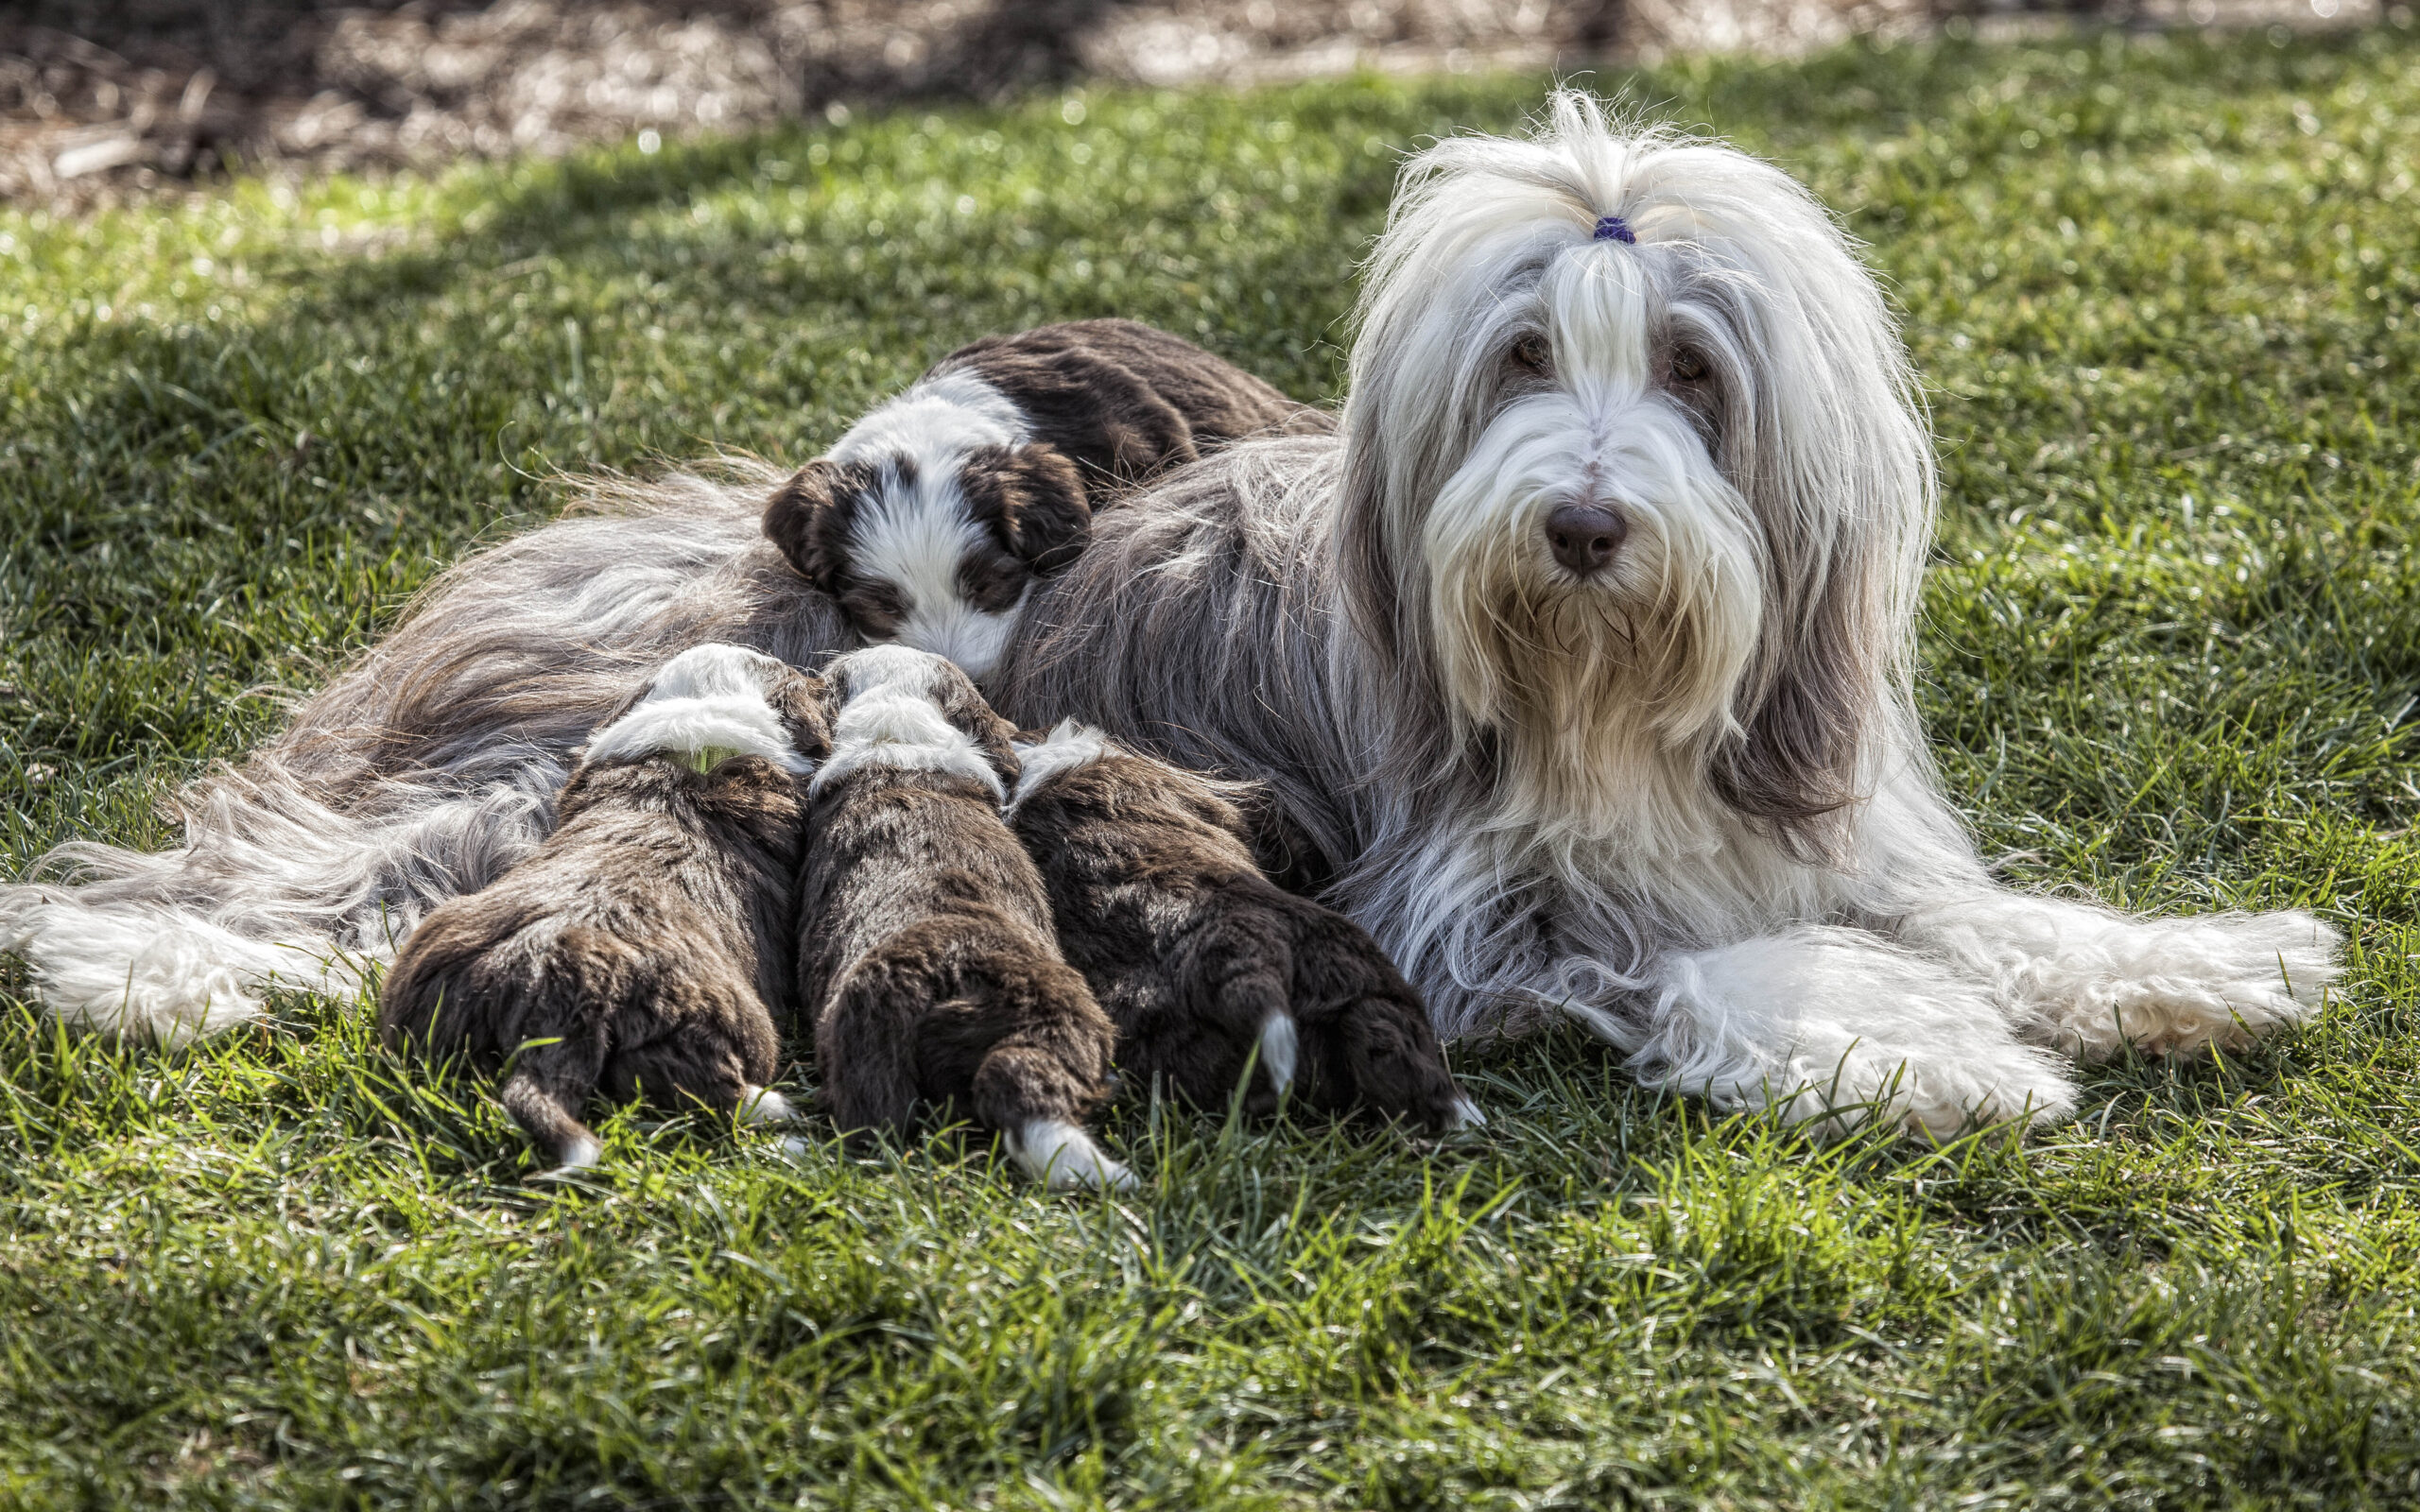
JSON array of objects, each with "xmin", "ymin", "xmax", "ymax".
[{"xmin": 0, "ymin": 890, "xmax": 360, "ymax": 1045}]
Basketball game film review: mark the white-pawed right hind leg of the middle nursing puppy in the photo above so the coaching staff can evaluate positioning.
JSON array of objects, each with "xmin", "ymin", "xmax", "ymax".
[{"xmin": 973, "ymin": 960, "xmax": 1135, "ymax": 1191}]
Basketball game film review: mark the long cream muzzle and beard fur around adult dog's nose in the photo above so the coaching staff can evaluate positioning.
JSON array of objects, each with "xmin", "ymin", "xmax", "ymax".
[{"xmin": 1426, "ymin": 394, "xmax": 1762, "ymax": 851}]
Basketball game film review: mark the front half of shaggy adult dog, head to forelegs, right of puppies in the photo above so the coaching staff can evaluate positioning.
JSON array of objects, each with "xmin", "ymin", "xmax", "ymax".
[{"xmin": 994, "ymin": 92, "xmax": 2335, "ymax": 1135}]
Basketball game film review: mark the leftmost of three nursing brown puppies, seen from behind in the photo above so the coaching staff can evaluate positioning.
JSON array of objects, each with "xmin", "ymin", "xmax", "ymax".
[{"xmin": 377, "ymin": 646, "xmax": 828, "ymax": 1168}]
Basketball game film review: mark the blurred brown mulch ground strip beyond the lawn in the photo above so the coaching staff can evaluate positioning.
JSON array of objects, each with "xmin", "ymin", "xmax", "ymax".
[{"xmin": 0, "ymin": 0, "xmax": 2378, "ymax": 206}]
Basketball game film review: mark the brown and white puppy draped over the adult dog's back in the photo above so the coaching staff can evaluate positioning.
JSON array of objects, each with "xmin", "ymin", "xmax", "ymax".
[{"xmin": 765, "ymin": 319, "xmax": 1331, "ymax": 678}]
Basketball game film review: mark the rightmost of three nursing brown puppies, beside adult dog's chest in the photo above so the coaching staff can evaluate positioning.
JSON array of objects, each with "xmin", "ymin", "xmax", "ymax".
[{"xmin": 1010, "ymin": 721, "xmax": 1486, "ymax": 1130}]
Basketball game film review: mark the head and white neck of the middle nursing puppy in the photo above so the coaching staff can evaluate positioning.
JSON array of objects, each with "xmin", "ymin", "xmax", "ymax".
[{"xmin": 813, "ymin": 646, "xmax": 1016, "ymax": 800}]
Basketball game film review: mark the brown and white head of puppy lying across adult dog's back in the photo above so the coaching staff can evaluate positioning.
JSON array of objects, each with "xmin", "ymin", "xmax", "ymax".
[{"xmin": 765, "ymin": 416, "xmax": 1092, "ymax": 678}]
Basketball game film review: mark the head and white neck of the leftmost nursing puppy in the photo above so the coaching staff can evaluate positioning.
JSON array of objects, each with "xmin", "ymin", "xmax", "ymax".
[{"xmin": 580, "ymin": 644, "xmax": 833, "ymax": 774}]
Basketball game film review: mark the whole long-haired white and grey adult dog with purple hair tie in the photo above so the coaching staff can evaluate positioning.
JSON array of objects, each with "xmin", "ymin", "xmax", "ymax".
[{"xmin": 0, "ymin": 92, "xmax": 2335, "ymax": 1132}]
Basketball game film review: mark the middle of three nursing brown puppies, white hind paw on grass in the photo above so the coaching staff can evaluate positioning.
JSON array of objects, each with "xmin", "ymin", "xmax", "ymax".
[{"xmin": 799, "ymin": 646, "xmax": 1132, "ymax": 1188}]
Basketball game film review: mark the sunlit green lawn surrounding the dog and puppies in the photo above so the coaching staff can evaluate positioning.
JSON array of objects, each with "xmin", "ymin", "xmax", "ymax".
[{"xmin": 0, "ymin": 17, "xmax": 2420, "ymax": 1507}]
